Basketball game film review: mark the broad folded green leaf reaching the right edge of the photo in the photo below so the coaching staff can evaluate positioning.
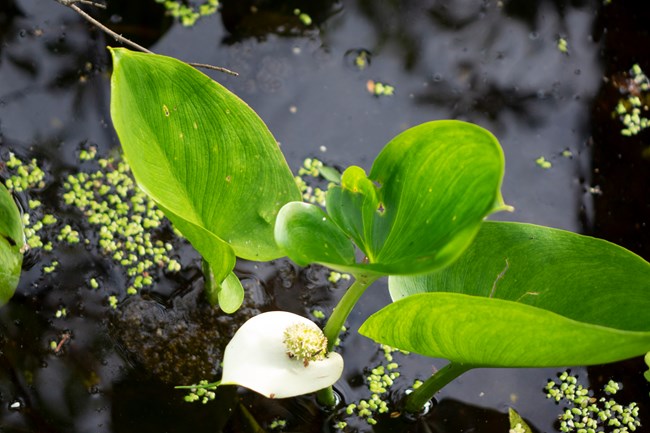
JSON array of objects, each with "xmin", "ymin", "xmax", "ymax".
[{"xmin": 360, "ymin": 222, "xmax": 650, "ymax": 367}]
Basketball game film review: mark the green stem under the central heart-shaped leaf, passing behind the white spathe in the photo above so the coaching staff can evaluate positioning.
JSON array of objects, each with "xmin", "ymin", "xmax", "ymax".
[{"xmin": 316, "ymin": 275, "xmax": 379, "ymax": 407}]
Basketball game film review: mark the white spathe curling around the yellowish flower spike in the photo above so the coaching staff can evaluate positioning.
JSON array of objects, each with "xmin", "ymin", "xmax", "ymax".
[{"xmin": 221, "ymin": 311, "xmax": 343, "ymax": 398}]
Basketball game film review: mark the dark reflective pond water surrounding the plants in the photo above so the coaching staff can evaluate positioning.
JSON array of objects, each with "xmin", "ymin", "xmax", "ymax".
[{"xmin": 0, "ymin": 0, "xmax": 650, "ymax": 432}]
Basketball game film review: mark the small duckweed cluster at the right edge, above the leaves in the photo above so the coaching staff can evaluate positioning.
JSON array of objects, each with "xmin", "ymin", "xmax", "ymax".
[{"xmin": 615, "ymin": 65, "xmax": 650, "ymax": 137}]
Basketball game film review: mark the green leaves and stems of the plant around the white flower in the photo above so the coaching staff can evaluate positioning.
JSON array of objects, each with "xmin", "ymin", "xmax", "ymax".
[{"xmin": 111, "ymin": 49, "xmax": 650, "ymax": 411}]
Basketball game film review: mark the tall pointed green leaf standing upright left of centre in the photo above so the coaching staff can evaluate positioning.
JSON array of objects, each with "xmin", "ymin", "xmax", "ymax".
[{"xmin": 111, "ymin": 48, "xmax": 300, "ymax": 300}]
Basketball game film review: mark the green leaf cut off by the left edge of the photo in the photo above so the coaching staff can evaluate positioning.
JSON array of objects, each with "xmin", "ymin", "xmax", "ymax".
[{"xmin": 0, "ymin": 183, "xmax": 25, "ymax": 306}]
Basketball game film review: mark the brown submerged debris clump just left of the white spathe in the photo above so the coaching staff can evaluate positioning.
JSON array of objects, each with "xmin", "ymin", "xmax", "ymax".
[{"xmin": 109, "ymin": 284, "xmax": 260, "ymax": 384}]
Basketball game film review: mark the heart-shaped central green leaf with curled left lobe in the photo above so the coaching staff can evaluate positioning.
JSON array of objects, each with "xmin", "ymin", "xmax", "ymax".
[{"xmin": 276, "ymin": 120, "xmax": 507, "ymax": 275}]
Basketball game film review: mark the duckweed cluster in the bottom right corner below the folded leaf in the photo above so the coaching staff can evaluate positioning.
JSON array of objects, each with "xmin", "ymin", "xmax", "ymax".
[{"xmin": 545, "ymin": 371, "xmax": 641, "ymax": 433}]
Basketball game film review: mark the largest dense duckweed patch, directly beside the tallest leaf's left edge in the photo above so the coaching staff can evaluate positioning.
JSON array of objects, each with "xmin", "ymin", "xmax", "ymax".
[{"xmin": 63, "ymin": 153, "xmax": 180, "ymax": 295}]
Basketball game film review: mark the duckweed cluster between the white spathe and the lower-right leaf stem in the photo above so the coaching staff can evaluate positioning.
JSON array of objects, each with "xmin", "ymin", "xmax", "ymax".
[{"xmin": 339, "ymin": 344, "xmax": 406, "ymax": 428}]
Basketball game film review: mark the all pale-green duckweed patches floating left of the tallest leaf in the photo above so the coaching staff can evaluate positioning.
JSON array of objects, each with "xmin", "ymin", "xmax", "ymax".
[{"xmin": 5, "ymin": 150, "xmax": 181, "ymax": 307}]
